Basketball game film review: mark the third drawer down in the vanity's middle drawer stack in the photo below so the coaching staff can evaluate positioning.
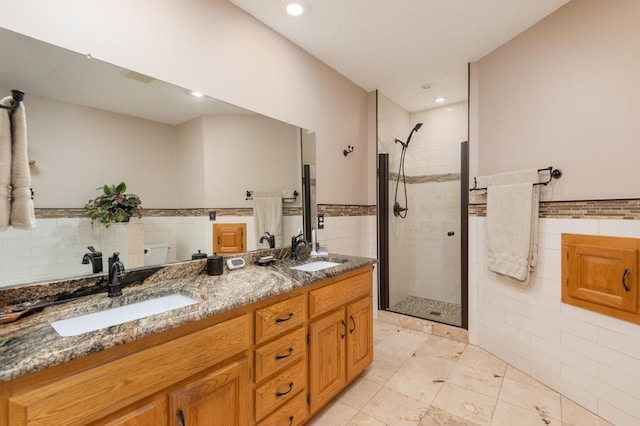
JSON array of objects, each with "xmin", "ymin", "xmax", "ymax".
[{"xmin": 256, "ymin": 361, "xmax": 306, "ymax": 420}]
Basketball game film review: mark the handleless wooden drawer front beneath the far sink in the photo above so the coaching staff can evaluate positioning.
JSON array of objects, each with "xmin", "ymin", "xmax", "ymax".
[{"xmin": 309, "ymin": 272, "xmax": 371, "ymax": 318}]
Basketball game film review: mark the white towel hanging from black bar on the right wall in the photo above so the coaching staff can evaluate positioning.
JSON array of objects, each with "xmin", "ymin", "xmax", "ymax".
[{"xmin": 487, "ymin": 169, "xmax": 540, "ymax": 285}]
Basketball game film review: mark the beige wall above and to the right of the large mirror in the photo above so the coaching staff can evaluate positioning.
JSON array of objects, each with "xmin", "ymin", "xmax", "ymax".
[{"xmin": 0, "ymin": 0, "xmax": 375, "ymax": 204}]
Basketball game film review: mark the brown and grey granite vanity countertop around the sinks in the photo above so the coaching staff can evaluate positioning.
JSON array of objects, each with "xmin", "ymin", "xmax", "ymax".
[{"xmin": 0, "ymin": 251, "xmax": 375, "ymax": 381}]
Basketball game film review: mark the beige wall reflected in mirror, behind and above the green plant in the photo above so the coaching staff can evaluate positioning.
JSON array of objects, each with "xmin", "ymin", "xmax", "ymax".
[{"xmin": 18, "ymin": 90, "xmax": 177, "ymax": 208}]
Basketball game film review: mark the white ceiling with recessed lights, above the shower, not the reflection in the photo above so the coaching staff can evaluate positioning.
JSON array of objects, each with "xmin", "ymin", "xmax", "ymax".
[{"xmin": 230, "ymin": 0, "xmax": 568, "ymax": 112}]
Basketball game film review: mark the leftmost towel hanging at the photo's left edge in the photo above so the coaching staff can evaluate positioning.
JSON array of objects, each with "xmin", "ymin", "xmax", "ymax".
[{"xmin": 0, "ymin": 96, "xmax": 14, "ymax": 231}]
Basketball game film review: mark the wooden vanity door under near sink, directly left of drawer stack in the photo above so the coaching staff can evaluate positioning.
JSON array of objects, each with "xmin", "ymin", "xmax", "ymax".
[{"xmin": 169, "ymin": 358, "xmax": 251, "ymax": 426}]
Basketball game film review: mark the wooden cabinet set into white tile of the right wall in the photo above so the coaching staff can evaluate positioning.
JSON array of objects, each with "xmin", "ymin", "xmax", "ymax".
[{"xmin": 562, "ymin": 234, "xmax": 640, "ymax": 323}]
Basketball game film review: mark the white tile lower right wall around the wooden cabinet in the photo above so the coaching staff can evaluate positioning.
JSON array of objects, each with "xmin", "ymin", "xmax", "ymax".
[{"xmin": 469, "ymin": 217, "xmax": 640, "ymax": 426}]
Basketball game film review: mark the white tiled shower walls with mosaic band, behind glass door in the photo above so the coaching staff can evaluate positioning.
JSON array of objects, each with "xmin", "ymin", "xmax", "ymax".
[{"xmin": 378, "ymin": 94, "xmax": 467, "ymax": 306}]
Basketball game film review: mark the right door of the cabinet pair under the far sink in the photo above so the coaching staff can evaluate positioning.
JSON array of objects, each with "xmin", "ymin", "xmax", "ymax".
[{"xmin": 346, "ymin": 297, "xmax": 373, "ymax": 381}]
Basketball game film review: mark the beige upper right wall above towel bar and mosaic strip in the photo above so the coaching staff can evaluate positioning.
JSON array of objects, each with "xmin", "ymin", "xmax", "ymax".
[{"xmin": 471, "ymin": 0, "xmax": 640, "ymax": 200}]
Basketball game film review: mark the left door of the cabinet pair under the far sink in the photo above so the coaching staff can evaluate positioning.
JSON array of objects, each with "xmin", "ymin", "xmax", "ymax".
[{"xmin": 309, "ymin": 309, "xmax": 347, "ymax": 413}]
